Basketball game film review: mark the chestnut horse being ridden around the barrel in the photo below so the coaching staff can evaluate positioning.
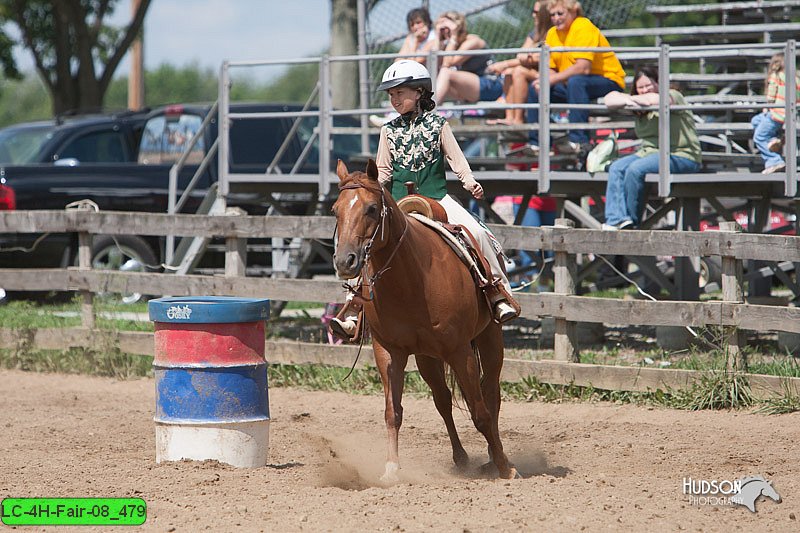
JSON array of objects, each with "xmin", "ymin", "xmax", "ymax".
[{"xmin": 333, "ymin": 159, "xmax": 518, "ymax": 482}]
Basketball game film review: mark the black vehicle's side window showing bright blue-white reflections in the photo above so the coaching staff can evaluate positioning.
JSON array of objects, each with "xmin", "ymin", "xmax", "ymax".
[{"xmin": 139, "ymin": 113, "xmax": 206, "ymax": 165}]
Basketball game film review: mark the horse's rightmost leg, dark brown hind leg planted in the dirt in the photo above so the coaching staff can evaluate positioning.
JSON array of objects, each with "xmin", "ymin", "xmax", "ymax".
[{"xmin": 448, "ymin": 338, "xmax": 518, "ymax": 479}]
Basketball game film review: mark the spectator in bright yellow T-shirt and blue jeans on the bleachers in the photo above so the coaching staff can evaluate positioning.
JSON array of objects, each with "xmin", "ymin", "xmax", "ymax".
[{"xmin": 527, "ymin": 0, "xmax": 625, "ymax": 153}]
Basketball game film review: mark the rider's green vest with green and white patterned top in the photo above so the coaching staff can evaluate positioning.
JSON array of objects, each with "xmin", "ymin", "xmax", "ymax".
[{"xmin": 384, "ymin": 112, "xmax": 447, "ymax": 200}]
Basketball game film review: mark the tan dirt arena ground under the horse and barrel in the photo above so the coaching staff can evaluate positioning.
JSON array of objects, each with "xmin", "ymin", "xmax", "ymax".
[{"xmin": 0, "ymin": 371, "xmax": 800, "ymax": 532}]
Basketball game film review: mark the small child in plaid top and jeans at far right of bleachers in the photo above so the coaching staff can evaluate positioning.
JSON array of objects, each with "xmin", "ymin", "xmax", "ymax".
[{"xmin": 750, "ymin": 54, "xmax": 800, "ymax": 174}]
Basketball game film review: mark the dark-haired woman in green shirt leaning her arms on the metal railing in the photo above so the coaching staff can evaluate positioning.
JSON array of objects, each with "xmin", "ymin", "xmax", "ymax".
[{"xmin": 602, "ymin": 66, "xmax": 702, "ymax": 230}]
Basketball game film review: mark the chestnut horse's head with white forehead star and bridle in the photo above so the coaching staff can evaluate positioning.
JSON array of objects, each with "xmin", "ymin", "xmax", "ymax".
[{"xmin": 333, "ymin": 159, "xmax": 387, "ymax": 279}]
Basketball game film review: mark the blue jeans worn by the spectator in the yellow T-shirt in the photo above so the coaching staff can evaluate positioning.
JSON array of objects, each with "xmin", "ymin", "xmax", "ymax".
[{"xmin": 527, "ymin": 74, "xmax": 624, "ymax": 145}]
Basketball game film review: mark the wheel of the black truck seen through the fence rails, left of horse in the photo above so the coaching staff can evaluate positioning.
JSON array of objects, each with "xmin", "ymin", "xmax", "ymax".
[{"xmin": 92, "ymin": 235, "xmax": 158, "ymax": 304}]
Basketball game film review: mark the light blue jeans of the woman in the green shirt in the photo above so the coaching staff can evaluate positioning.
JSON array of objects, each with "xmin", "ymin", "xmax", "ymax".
[{"xmin": 606, "ymin": 154, "xmax": 700, "ymax": 226}]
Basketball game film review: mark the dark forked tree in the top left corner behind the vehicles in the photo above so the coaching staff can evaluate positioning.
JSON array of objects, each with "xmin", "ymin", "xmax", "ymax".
[{"xmin": 0, "ymin": 0, "xmax": 151, "ymax": 114}]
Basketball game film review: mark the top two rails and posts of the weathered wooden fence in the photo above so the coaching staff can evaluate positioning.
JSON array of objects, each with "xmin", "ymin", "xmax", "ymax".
[{"xmin": 0, "ymin": 211, "xmax": 800, "ymax": 370}]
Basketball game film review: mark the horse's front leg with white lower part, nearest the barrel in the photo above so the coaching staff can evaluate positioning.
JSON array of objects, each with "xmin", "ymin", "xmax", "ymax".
[{"xmin": 372, "ymin": 338, "xmax": 408, "ymax": 483}]
